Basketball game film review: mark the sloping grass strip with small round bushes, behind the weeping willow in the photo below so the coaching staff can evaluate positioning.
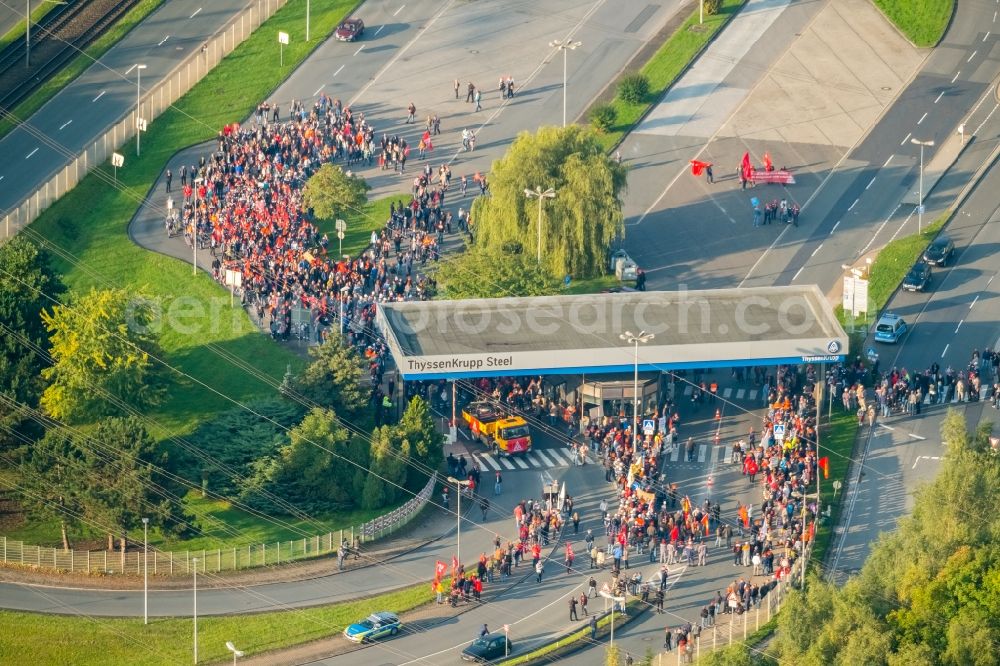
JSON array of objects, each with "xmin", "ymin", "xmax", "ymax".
[{"xmin": 601, "ymin": 0, "xmax": 746, "ymax": 150}]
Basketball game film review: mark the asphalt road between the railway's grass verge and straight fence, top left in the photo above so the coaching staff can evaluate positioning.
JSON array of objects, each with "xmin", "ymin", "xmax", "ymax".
[{"xmin": 0, "ymin": 0, "xmax": 258, "ymax": 211}]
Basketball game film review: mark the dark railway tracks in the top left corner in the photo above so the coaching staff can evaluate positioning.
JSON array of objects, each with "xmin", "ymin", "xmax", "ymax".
[{"xmin": 0, "ymin": 0, "xmax": 139, "ymax": 111}]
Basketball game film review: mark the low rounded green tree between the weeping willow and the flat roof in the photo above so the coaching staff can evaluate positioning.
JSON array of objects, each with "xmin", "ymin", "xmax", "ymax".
[{"xmin": 435, "ymin": 246, "xmax": 559, "ymax": 300}]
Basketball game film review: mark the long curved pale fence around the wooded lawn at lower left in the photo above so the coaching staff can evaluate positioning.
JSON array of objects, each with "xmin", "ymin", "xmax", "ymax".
[{"xmin": 0, "ymin": 473, "xmax": 437, "ymax": 576}]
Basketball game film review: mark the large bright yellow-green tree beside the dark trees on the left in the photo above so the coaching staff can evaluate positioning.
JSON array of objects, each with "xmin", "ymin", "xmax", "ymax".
[{"xmin": 41, "ymin": 289, "xmax": 164, "ymax": 422}]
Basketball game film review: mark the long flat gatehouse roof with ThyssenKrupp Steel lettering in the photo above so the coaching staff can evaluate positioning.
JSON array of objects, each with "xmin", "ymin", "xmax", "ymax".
[{"xmin": 377, "ymin": 286, "xmax": 848, "ymax": 379}]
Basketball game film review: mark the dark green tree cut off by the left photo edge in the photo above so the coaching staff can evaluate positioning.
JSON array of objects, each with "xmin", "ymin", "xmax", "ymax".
[{"xmin": 0, "ymin": 236, "xmax": 65, "ymax": 447}]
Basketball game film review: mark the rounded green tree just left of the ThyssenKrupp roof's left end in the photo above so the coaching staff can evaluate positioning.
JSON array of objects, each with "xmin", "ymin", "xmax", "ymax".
[{"xmin": 295, "ymin": 336, "xmax": 368, "ymax": 419}]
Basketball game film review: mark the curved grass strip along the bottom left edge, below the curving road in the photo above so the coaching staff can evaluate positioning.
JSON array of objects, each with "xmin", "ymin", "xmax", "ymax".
[{"xmin": 0, "ymin": 572, "xmax": 431, "ymax": 666}]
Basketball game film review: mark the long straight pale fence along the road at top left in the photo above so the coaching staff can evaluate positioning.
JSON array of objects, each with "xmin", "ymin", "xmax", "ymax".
[{"xmin": 4, "ymin": 0, "xmax": 288, "ymax": 239}]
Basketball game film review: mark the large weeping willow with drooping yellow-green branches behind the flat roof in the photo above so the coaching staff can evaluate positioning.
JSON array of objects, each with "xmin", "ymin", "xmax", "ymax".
[{"xmin": 471, "ymin": 125, "xmax": 625, "ymax": 277}]
